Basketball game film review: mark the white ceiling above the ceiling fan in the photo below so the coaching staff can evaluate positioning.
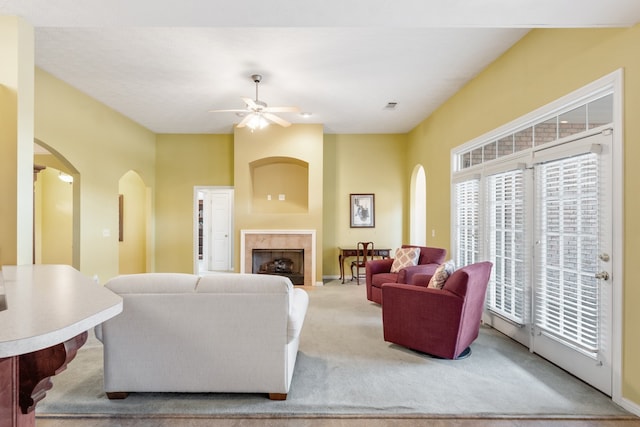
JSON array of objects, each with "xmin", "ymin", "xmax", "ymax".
[{"xmin": 0, "ymin": 0, "xmax": 640, "ymax": 133}]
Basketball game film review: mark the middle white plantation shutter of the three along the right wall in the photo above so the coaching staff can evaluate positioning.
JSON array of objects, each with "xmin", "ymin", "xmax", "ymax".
[{"xmin": 486, "ymin": 170, "xmax": 529, "ymax": 324}]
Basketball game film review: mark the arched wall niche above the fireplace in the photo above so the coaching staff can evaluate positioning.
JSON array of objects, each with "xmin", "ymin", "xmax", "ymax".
[{"xmin": 249, "ymin": 157, "xmax": 309, "ymax": 214}]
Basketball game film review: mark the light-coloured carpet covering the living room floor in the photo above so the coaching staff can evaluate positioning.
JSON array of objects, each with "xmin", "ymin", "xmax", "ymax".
[{"xmin": 37, "ymin": 281, "xmax": 629, "ymax": 417}]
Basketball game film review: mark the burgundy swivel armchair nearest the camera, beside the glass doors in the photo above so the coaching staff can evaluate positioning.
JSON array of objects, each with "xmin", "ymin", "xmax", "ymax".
[{"xmin": 382, "ymin": 261, "xmax": 493, "ymax": 359}]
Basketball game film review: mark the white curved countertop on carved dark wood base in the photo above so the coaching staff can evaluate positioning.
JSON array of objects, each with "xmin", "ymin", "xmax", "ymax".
[{"xmin": 0, "ymin": 265, "xmax": 122, "ymax": 358}]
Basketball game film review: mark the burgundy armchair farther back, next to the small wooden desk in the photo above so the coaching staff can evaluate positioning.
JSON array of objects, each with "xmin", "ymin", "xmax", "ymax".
[{"xmin": 365, "ymin": 245, "xmax": 447, "ymax": 304}]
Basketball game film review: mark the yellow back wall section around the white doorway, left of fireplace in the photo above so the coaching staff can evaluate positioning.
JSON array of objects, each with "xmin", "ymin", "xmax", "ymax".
[{"xmin": 155, "ymin": 135, "xmax": 233, "ymax": 273}]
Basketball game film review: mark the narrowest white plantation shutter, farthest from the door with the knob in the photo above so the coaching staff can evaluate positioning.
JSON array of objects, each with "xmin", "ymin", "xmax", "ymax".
[{"xmin": 454, "ymin": 178, "xmax": 480, "ymax": 266}]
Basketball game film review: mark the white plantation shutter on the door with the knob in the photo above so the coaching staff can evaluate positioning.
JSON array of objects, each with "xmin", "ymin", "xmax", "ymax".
[{"xmin": 534, "ymin": 153, "xmax": 600, "ymax": 354}]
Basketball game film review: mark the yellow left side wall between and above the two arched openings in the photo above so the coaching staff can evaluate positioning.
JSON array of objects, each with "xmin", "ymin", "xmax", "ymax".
[{"xmin": 35, "ymin": 68, "xmax": 155, "ymax": 282}]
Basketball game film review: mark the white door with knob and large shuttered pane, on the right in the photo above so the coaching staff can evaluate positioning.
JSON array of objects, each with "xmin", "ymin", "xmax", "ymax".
[{"xmin": 531, "ymin": 130, "xmax": 613, "ymax": 395}]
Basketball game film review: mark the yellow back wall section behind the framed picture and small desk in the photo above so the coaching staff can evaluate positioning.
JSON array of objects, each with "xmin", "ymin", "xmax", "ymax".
[{"xmin": 323, "ymin": 134, "xmax": 411, "ymax": 276}]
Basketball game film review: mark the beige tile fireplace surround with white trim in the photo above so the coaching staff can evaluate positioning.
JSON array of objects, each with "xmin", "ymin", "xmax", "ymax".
[{"xmin": 240, "ymin": 230, "xmax": 316, "ymax": 286}]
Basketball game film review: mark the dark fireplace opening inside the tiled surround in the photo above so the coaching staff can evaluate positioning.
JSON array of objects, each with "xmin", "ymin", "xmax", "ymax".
[{"xmin": 251, "ymin": 249, "xmax": 304, "ymax": 285}]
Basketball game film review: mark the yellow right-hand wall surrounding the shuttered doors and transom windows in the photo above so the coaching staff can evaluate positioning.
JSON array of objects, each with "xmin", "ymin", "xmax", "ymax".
[{"xmin": 405, "ymin": 25, "xmax": 640, "ymax": 404}]
